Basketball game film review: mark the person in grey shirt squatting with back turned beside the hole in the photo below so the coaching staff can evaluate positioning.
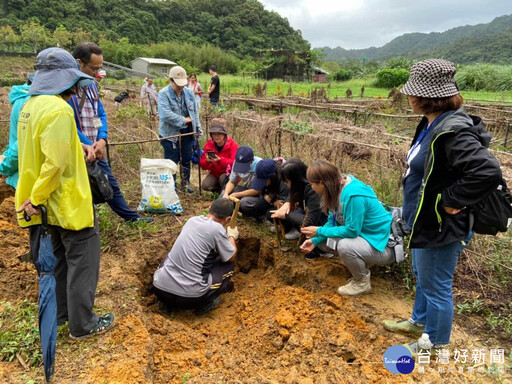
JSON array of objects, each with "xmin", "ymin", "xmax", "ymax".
[{"xmin": 153, "ymin": 198, "xmax": 238, "ymax": 315}]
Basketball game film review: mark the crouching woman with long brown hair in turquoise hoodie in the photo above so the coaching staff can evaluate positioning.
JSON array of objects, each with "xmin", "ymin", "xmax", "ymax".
[{"xmin": 301, "ymin": 160, "xmax": 395, "ymax": 296}]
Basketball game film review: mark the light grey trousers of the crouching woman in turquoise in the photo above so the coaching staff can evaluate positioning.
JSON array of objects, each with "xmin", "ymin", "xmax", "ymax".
[{"xmin": 319, "ymin": 236, "xmax": 395, "ymax": 280}]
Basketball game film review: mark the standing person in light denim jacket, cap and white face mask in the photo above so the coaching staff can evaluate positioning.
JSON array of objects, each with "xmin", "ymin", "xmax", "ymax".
[{"xmin": 158, "ymin": 66, "xmax": 203, "ymax": 193}]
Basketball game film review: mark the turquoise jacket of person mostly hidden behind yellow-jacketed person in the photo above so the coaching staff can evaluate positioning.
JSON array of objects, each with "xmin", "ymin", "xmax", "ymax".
[{"xmin": 0, "ymin": 84, "xmax": 30, "ymax": 194}]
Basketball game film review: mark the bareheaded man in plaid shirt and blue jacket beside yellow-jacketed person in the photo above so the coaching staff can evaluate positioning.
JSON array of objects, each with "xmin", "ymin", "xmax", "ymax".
[{"xmin": 69, "ymin": 42, "xmax": 154, "ymax": 222}]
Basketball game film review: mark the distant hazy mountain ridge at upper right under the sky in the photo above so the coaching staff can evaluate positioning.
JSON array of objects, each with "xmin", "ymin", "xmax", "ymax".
[{"xmin": 319, "ymin": 15, "xmax": 512, "ymax": 64}]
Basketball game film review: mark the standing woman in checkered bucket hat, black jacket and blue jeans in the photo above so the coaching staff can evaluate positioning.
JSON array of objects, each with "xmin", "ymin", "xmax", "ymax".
[{"xmin": 384, "ymin": 59, "xmax": 501, "ymax": 353}]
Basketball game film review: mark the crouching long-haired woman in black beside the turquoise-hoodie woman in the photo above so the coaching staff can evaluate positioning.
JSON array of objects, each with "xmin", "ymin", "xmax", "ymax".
[{"xmin": 270, "ymin": 159, "xmax": 327, "ymax": 258}]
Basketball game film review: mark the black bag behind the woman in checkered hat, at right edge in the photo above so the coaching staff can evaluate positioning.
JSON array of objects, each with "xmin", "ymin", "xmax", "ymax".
[{"xmin": 470, "ymin": 178, "xmax": 512, "ymax": 236}]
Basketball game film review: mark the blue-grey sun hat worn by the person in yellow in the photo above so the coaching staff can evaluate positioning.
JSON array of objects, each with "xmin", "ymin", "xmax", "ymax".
[{"xmin": 29, "ymin": 47, "xmax": 94, "ymax": 95}]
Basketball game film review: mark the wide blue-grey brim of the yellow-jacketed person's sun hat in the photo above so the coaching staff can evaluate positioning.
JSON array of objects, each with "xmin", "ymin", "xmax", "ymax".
[{"xmin": 29, "ymin": 68, "xmax": 94, "ymax": 95}]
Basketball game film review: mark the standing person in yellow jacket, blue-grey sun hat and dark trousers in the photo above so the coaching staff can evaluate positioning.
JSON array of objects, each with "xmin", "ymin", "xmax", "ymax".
[{"xmin": 16, "ymin": 48, "xmax": 114, "ymax": 339}]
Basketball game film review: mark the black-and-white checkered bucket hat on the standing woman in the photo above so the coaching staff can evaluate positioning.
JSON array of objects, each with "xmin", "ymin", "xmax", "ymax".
[{"xmin": 400, "ymin": 59, "xmax": 459, "ymax": 99}]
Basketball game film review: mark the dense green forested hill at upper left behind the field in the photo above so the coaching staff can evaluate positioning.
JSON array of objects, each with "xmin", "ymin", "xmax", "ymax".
[{"xmin": 0, "ymin": 0, "xmax": 309, "ymax": 57}]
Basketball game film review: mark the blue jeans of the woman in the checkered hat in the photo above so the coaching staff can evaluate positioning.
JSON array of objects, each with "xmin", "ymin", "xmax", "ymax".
[{"xmin": 412, "ymin": 232, "xmax": 473, "ymax": 345}]
